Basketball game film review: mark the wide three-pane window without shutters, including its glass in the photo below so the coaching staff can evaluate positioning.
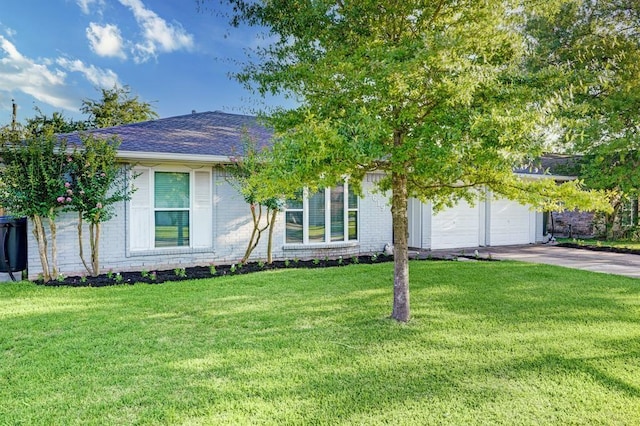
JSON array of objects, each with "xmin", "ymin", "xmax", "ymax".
[{"xmin": 285, "ymin": 183, "xmax": 358, "ymax": 244}]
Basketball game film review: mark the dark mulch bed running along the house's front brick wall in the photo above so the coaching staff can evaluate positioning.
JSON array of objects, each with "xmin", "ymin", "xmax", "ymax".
[{"xmin": 35, "ymin": 254, "xmax": 393, "ymax": 287}]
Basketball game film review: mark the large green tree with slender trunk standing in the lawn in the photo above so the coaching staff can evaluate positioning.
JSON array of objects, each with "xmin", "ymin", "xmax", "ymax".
[{"xmin": 211, "ymin": 0, "xmax": 602, "ymax": 321}]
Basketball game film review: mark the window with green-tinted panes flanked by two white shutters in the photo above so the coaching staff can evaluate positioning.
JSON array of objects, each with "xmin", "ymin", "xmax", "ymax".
[{"xmin": 129, "ymin": 167, "xmax": 212, "ymax": 251}]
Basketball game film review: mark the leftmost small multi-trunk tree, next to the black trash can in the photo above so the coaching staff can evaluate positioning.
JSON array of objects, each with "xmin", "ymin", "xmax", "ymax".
[{"xmin": 0, "ymin": 135, "xmax": 68, "ymax": 281}]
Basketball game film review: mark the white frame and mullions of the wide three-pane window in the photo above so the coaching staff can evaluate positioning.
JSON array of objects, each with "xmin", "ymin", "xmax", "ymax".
[{"xmin": 284, "ymin": 181, "xmax": 360, "ymax": 246}]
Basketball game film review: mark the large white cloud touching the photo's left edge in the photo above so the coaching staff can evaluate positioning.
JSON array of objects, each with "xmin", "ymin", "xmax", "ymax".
[{"xmin": 0, "ymin": 35, "xmax": 118, "ymax": 111}]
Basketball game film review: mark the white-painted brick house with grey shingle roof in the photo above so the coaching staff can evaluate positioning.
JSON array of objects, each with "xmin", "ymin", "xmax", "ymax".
[{"xmin": 29, "ymin": 112, "xmax": 544, "ymax": 277}]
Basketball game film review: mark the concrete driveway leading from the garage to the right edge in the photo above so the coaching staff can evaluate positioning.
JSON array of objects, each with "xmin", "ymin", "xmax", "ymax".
[{"xmin": 427, "ymin": 244, "xmax": 640, "ymax": 278}]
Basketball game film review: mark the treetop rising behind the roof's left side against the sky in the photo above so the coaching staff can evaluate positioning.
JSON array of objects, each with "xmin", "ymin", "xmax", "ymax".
[{"xmin": 80, "ymin": 86, "xmax": 158, "ymax": 128}]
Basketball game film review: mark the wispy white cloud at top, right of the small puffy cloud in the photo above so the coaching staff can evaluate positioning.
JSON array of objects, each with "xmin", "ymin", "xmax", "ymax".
[{"xmin": 120, "ymin": 0, "xmax": 193, "ymax": 62}]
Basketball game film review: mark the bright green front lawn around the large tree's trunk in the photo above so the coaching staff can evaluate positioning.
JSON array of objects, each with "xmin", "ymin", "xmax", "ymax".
[{"xmin": 0, "ymin": 262, "xmax": 640, "ymax": 425}]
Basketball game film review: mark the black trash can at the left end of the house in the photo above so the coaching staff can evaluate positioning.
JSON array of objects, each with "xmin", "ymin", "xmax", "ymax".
[{"xmin": 0, "ymin": 216, "xmax": 27, "ymax": 281}]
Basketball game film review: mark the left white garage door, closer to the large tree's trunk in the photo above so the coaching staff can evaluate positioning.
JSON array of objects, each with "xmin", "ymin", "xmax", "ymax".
[{"xmin": 431, "ymin": 200, "xmax": 484, "ymax": 249}]
